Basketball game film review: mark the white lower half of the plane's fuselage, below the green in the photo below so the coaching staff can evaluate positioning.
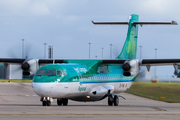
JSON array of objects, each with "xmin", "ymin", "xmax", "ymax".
[{"xmin": 32, "ymin": 82, "xmax": 132, "ymax": 101}]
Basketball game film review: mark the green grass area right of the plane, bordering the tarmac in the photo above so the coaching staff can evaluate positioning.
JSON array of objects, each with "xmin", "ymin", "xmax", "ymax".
[{"xmin": 126, "ymin": 82, "xmax": 180, "ymax": 103}]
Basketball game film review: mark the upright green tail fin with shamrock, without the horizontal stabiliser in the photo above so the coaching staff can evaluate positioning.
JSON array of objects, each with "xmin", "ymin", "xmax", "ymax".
[{"xmin": 116, "ymin": 14, "xmax": 139, "ymax": 59}]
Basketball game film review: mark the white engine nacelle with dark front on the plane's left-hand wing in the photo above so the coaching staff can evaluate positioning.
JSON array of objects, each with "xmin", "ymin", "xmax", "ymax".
[{"xmin": 21, "ymin": 59, "xmax": 39, "ymax": 76}]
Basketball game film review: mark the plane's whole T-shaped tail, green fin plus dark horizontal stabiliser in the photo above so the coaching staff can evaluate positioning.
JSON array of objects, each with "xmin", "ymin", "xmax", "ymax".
[{"xmin": 92, "ymin": 14, "xmax": 177, "ymax": 59}]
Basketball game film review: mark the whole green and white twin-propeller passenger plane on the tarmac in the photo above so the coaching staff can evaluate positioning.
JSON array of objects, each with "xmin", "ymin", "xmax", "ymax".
[{"xmin": 0, "ymin": 14, "xmax": 180, "ymax": 106}]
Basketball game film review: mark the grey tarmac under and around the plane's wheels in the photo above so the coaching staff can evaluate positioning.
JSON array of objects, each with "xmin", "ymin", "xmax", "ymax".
[{"xmin": 0, "ymin": 83, "xmax": 180, "ymax": 120}]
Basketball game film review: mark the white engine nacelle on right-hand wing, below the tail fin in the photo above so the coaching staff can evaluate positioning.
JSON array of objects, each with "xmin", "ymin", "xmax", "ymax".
[{"xmin": 122, "ymin": 60, "xmax": 140, "ymax": 76}]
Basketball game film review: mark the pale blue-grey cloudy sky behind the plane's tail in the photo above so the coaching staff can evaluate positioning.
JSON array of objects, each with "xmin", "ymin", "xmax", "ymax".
[{"xmin": 0, "ymin": 0, "xmax": 180, "ymax": 77}]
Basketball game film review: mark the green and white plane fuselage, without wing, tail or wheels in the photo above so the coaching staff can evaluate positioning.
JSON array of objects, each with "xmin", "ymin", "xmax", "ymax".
[{"xmin": 32, "ymin": 64, "xmax": 136, "ymax": 101}]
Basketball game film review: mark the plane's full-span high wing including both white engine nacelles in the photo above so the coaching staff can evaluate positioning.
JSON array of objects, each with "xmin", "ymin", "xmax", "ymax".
[{"xmin": 0, "ymin": 58, "xmax": 180, "ymax": 76}]
